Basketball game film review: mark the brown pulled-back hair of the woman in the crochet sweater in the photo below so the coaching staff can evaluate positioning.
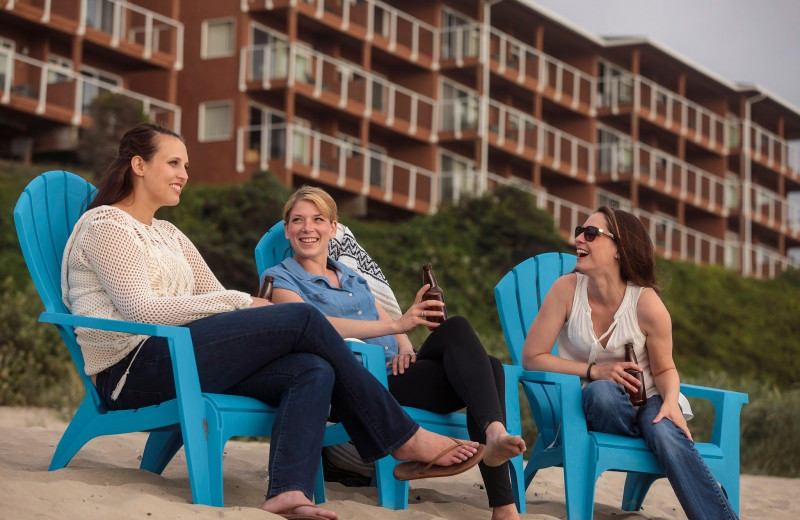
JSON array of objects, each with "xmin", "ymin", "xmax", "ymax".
[{"xmin": 89, "ymin": 123, "xmax": 183, "ymax": 209}]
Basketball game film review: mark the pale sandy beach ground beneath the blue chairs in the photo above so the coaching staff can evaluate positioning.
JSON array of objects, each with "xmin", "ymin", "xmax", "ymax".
[{"xmin": 0, "ymin": 407, "xmax": 788, "ymax": 520}]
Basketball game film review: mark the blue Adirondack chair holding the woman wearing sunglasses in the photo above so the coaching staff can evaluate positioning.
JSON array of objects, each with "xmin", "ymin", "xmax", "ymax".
[{"xmin": 495, "ymin": 253, "xmax": 748, "ymax": 520}]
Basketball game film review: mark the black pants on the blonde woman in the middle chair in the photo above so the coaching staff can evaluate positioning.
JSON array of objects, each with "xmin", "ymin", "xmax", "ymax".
[{"xmin": 389, "ymin": 316, "xmax": 514, "ymax": 507}]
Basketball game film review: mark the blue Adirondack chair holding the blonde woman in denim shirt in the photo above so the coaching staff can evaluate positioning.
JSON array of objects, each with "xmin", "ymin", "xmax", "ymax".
[{"xmin": 255, "ymin": 221, "xmax": 525, "ymax": 513}]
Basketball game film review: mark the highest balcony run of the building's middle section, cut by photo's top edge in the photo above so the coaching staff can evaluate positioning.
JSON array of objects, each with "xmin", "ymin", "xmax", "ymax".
[{"xmin": 248, "ymin": 0, "xmax": 439, "ymax": 69}]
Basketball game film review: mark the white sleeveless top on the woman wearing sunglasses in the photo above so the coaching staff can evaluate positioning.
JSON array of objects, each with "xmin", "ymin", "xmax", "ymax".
[{"xmin": 558, "ymin": 273, "xmax": 694, "ymax": 421}]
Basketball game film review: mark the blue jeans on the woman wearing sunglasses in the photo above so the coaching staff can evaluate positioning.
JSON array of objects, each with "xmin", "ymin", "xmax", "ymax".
[{"xmin": 583, "ymin": 380, "xmax": 738, "ymax": 520}]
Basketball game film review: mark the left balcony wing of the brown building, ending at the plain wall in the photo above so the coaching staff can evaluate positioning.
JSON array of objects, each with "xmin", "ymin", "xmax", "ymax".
[{"xmin": 0, "ymin": 0, "xmax": 184, "ymax": 161}]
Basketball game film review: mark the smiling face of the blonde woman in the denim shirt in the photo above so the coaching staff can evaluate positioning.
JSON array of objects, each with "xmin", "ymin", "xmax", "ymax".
[{"xmin": 283, "ymin": 200, "xmax": 336, "ymax": 260}]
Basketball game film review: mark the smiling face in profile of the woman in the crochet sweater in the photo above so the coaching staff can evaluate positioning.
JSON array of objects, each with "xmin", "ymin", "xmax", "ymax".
[{"xmin": 131, "ymin": 135, "xmax": 189, "ymax": 211}]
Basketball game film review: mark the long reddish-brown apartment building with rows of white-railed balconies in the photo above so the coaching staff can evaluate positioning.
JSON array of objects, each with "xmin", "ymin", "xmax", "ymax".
[{"xmin": 0, "ymin": 0, "xmax": 800, "ymax": 277}]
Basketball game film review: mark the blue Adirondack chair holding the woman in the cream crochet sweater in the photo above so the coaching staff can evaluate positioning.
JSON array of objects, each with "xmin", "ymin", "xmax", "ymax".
[{"xmin": 14, "ymin": 171, "xmax": 384, "ymax": 506}]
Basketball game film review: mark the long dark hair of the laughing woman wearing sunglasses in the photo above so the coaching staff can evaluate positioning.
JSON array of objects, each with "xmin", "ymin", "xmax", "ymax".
[{"xmin": 596, "ymin": 206, "xmax": 661, "ymax": 296}]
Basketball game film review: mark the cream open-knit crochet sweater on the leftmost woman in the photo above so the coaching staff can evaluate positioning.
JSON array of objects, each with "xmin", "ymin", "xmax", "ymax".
[{"xmin": 61, "ymin": 206, "xmax": 253, "ymax": 375}]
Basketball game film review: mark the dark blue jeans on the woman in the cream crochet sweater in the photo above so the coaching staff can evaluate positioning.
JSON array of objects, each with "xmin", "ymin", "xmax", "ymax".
[{"xmin": 97, "ymin": 303, "xmax": 419, "ymax": 498}]
